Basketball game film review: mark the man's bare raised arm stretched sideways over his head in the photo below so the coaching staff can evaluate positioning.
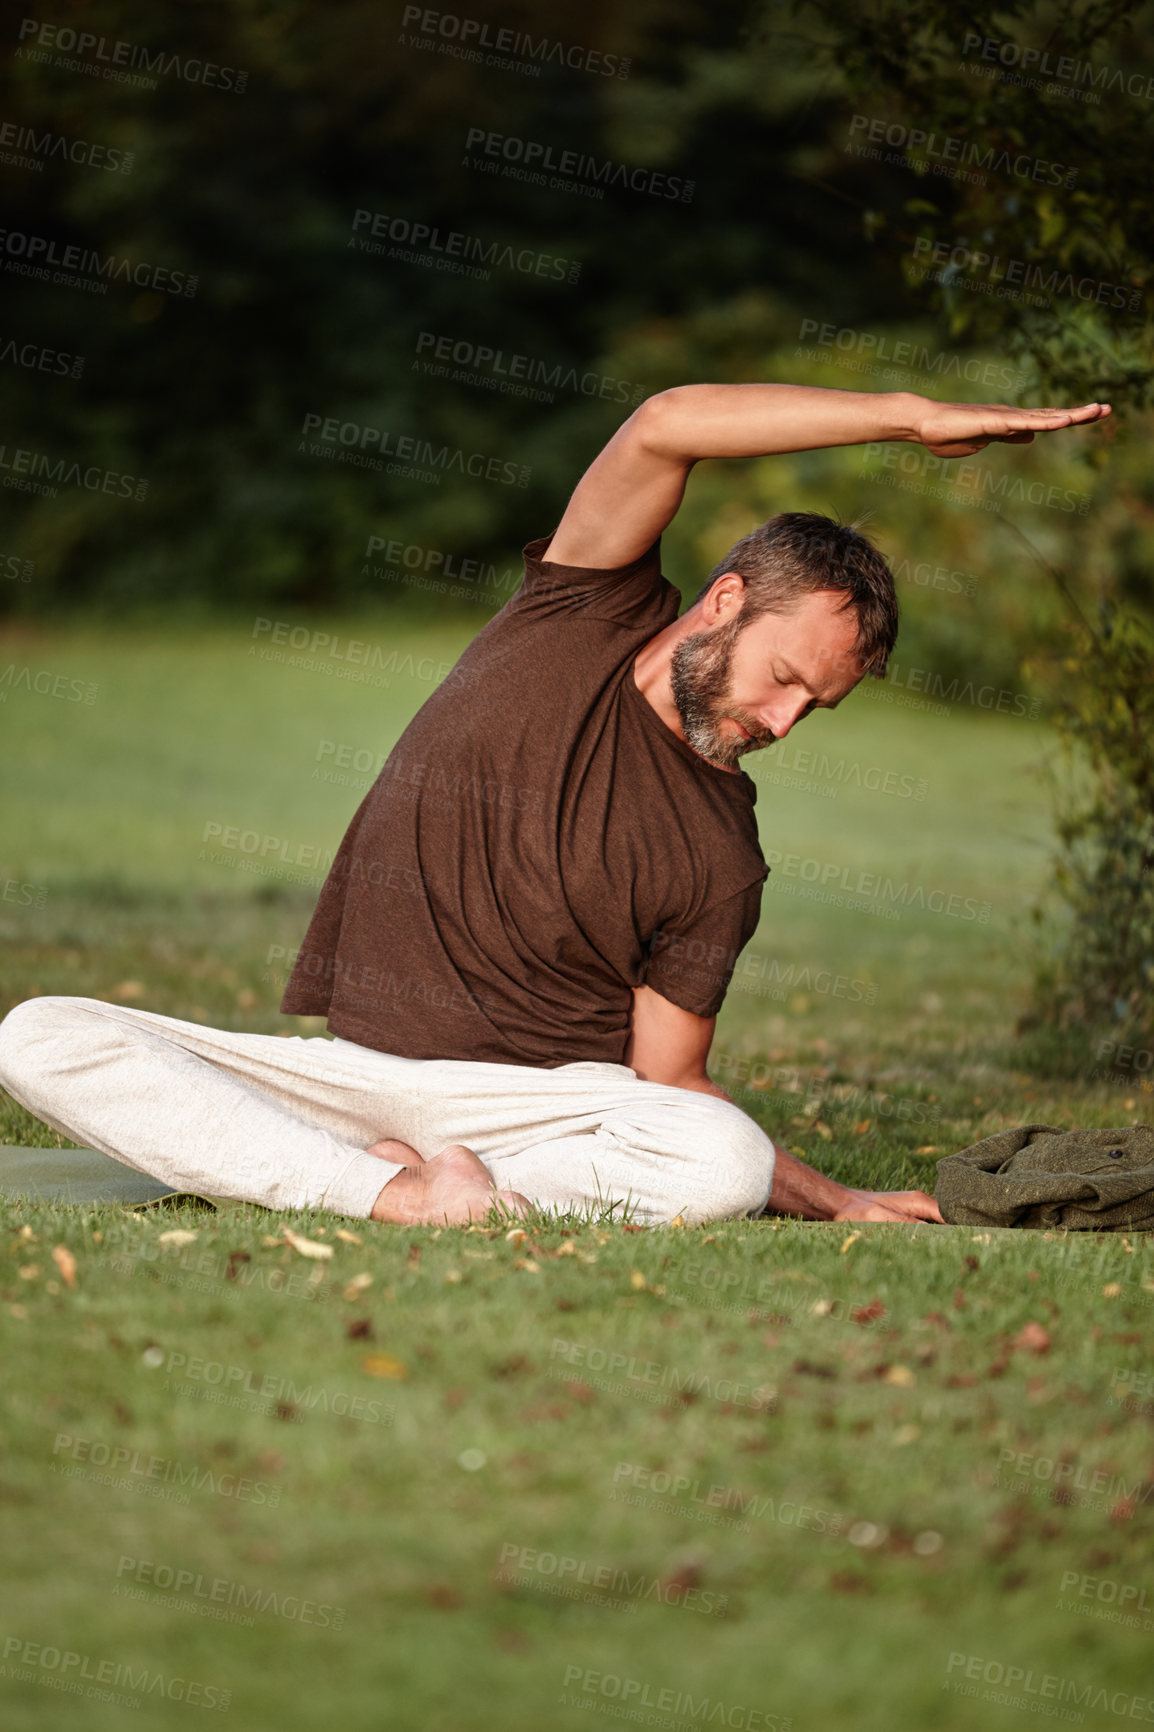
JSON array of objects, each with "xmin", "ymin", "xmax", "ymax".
[{"xmin": 548, "ymin": 385, "xmax": 1111, "ymax": 568}]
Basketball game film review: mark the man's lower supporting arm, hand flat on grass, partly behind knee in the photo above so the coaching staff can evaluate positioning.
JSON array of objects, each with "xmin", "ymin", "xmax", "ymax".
[{"xmin": 626, "ymin": 986, "xmax": 941, "ymax": 1223}]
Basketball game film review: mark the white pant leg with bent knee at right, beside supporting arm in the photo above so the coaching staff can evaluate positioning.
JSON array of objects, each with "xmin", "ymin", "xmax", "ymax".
[{"xmin": 403, "ymin": 1060, "xmax": 775, "ymax": 1226}]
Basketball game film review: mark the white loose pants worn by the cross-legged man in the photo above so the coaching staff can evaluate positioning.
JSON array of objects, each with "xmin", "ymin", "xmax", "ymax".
[{"xmin": 0, "ymin": 998, "xmax": 775, "ymax": 1226}]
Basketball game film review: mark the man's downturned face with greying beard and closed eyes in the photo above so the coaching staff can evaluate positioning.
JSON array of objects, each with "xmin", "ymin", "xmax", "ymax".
[{"xmin": 671, "ymin": 589, "xmax": 863, "ymax": 769}]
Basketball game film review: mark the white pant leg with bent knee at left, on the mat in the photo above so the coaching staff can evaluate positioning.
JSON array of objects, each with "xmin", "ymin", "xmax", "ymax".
[{"xmin": 0, "ymin": 998, "xmax": 423, "ymax": 1218}]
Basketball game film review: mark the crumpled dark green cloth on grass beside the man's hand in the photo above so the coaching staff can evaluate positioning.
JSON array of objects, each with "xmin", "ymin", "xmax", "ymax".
[{"xmin": 934, "ymin": 1124, "xmax": 1154, "ymax": 1233}]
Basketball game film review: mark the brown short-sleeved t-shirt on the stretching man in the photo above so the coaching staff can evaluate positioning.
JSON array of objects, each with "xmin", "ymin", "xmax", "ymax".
[{"xmin": 281, "ymin": 535, "xmax": 766, "ymax": 1067}]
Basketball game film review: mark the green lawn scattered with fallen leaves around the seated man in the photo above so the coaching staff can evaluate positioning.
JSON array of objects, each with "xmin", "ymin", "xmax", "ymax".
[{"xmin": 0, "ymin": 620, "xmax": 1154, "ymax": 1732}]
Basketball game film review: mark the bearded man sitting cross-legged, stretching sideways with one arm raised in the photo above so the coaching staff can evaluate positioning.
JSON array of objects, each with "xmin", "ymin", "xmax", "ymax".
[{"xmin": 0, "ymin": 385, "xmax": 1109, "ymax": 1223}]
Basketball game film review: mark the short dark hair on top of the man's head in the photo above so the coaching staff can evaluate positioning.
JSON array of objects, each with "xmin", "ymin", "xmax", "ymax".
[{"xmin": 695, "ymin": 511, "xmax": 898, "ymax": 679}]
